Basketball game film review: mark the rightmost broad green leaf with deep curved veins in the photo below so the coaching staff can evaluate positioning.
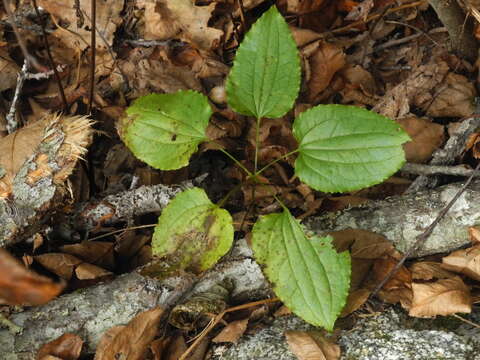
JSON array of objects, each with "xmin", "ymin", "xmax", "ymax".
[{"xmin": 293, "ymin": 105, "xmax": 410, "ymax": 192}]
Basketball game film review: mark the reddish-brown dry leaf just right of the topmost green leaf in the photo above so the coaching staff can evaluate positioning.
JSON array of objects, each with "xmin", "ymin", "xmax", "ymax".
[{"xmin": 303, "ymin": 42, "xmax": 345, "ymax": 101}]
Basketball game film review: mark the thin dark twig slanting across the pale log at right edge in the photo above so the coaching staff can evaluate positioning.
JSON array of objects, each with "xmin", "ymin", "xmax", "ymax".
[{"xmin": 370, "ymin": 161, "xmax": 480, "ymax": 297}]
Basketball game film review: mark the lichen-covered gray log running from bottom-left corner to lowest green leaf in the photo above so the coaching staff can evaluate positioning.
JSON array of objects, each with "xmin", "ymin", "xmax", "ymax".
[{"xmin": 0, "ymin": 241, "xmax": 271, "ymax": 360}]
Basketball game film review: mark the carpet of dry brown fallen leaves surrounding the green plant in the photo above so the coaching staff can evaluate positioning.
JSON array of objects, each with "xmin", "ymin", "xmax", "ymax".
[{"xmin": 0, "ymin": 0, "xmax": 480, "ymax": 359}]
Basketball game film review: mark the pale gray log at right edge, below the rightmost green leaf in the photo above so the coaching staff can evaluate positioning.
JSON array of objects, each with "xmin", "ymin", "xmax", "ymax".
[{"xmin": 306, "ymin": 180, "xmax": 480, "ymax": 257}]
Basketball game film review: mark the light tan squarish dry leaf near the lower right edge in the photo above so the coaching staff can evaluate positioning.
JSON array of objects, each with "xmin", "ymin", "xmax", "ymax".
[{"xmin": 409, "ymin": 276, "xmax": 472, "ymax": 317}]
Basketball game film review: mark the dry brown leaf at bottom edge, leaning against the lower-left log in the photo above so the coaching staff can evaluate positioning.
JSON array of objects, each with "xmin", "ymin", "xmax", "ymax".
[{"xmin": 95, "ymin": 307, "xmax": 163, "ymax": 360}]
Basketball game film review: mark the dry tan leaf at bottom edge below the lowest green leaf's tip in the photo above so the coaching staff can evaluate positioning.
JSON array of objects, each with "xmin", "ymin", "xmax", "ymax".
[{"xmin": 285, "ymin": 330, "xmax": 340, "ymax": 360}]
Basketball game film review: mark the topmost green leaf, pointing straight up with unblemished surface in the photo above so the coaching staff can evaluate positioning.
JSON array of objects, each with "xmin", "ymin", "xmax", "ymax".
[{"xmin": 226, "ymin": 6, "xmax": 300, "ymax": 119}]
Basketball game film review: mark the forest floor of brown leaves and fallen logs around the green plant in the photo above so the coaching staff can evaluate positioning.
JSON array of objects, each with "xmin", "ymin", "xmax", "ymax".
[{"xmin": 0, "ymin": 0, "xmax": 480, "ymax": 360}]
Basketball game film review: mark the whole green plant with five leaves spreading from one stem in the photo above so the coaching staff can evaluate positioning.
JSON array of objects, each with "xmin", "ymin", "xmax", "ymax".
[{"xmin": 121, "ymin": 7, "xmax": 409, "ymax": 330}]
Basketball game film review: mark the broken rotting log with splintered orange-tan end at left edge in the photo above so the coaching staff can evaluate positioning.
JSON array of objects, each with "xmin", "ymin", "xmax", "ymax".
[{"xmin": 0, "ymin": 114, "xmax": 92, "ymax": 247}]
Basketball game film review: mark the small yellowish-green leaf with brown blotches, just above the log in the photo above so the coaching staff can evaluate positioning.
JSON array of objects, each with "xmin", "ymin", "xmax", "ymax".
[{"xmin": 152, "ymin": 188, "xmax": 233, "ymax": 273}]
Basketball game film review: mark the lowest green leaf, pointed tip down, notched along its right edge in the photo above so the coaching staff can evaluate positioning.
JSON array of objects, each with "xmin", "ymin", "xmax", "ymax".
[{"xmin": 252, "ymin": 209, "xmax": 350, "ymax": 331}]
